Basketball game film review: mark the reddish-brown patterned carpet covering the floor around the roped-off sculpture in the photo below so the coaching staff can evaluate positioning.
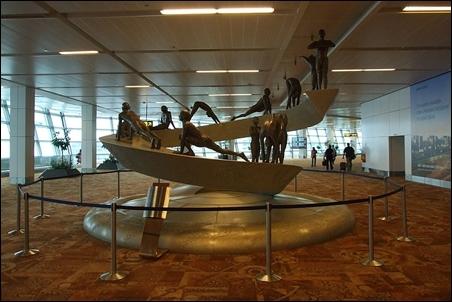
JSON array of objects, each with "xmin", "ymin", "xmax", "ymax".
[{"xmin": 1, "ymin": 164, "xmax": 451, "ymax": 301}]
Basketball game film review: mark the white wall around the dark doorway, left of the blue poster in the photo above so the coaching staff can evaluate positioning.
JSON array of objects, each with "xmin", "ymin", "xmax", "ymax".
[{"xmin": 361, "ymin": 87, "xmax": 411, "ymax": 174}]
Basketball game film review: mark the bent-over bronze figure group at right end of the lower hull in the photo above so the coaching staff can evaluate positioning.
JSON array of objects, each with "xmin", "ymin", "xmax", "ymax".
[{"xmin": 260, "ymin": 114, "xmax": 288, "ymax": 163}]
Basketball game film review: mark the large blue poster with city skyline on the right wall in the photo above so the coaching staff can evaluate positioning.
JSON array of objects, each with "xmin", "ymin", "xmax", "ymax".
[{"xmin": 411, "ymin": 72, "xmax": 451, "ymax": 181}]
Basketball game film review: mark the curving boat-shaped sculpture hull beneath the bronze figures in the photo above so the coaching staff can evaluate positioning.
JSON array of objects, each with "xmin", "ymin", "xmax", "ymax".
[{"xmin": 99, "ymin": 89, "xmax": 338, "ymax": 195}]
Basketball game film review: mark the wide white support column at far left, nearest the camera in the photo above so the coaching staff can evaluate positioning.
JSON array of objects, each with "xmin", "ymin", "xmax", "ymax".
[{"xmin": 9, "ymin": 86, "xmax": 35, "ymax": 184}]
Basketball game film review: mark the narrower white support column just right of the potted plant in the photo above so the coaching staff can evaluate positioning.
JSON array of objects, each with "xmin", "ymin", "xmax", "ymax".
[{"xmin": 82, "ymin": 104, "xmax": 97, "ymax": 169}]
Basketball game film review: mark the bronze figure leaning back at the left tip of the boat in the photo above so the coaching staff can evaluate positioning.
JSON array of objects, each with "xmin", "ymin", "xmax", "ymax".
[{"xmin": 116, "ymin": 102, "xmax": 161, "ymax": 149}]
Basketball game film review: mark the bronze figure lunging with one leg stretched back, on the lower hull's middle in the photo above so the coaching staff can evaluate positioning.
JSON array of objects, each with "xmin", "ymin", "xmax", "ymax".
[{"xmin": 179, "ymin": 110, "xmax": 249, "ymax": 162}]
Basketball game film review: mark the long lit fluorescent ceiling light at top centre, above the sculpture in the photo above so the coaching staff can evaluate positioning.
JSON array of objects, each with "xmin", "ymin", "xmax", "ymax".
[{"xmin": 160, "ymin": 7, "xmax": 275, "ymax": 15}]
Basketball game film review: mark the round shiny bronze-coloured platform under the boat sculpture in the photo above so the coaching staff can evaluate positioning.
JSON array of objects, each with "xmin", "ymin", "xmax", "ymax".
[{"xmin": 83, "ymin": 185, "xmax": 355, "ymax": 254}]
